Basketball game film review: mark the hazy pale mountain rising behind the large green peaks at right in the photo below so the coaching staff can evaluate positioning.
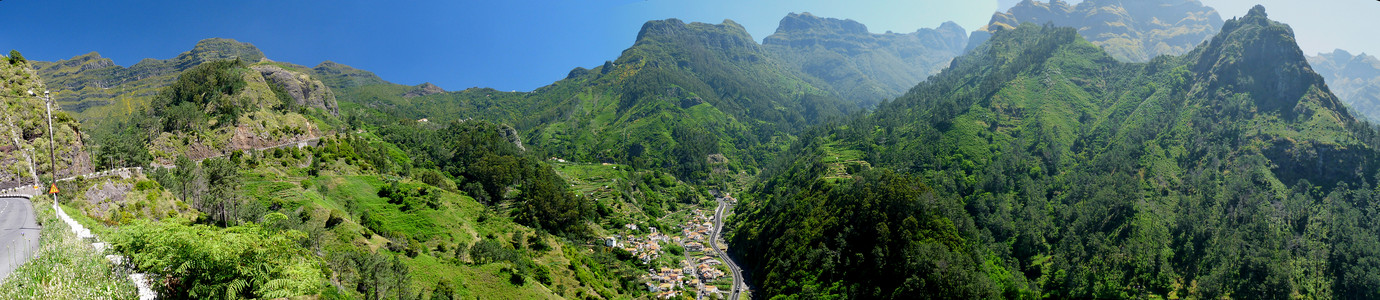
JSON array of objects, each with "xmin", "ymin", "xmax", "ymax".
[{"xmin": 969, "ymin": 0, "xmax": 1223, "ymax": 62}]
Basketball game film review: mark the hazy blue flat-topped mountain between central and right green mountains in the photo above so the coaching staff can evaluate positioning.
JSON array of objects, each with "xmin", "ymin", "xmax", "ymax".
[{"xmin": 762, "ymin": 12, "xmax": 967, "ymax": 106}]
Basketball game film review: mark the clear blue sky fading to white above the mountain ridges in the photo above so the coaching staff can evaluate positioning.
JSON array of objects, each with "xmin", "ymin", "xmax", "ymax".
[{"xmin": 0, "ymin": 0, "xmax": 1380, "ymax": 90}]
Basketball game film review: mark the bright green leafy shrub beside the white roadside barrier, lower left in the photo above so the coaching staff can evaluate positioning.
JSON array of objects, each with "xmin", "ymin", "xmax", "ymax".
[{"xmin": 110, "ymin": 220, "xmax": 326, "ymax": 299}]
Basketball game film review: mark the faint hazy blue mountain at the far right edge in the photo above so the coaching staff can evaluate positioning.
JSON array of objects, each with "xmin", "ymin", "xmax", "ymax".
[{"xmin": 1308, "ymin": 48, "xmax": 1380, "ymax": 120}]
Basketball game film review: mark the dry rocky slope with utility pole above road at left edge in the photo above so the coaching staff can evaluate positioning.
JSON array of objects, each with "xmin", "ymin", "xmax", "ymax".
[{"xmin": 0, "ymin": 51, "xmax": 92, "ymax": 188}]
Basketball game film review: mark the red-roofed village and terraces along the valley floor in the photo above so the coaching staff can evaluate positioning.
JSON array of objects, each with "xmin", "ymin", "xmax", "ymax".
[{"xmin": 549, "ymin": 158, "xmax": 737, "ymax": 300}]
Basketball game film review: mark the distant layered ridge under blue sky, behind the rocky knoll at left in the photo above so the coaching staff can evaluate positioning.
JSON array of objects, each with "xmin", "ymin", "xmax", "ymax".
[{"xmin": 33, "ymin": 39, "xmax": 335, "ymax": 126}]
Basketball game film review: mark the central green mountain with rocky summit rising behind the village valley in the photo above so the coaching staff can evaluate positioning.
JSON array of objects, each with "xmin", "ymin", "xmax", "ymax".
[{"xmin": 327, "ymin": 19, "xmax": 856, "ymax": 180}]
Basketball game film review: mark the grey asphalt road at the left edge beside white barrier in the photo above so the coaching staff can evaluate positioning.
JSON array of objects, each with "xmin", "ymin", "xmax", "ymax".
[{"xmin": 0, "ymin": 198, "xmax": 39, "ymax": 281}]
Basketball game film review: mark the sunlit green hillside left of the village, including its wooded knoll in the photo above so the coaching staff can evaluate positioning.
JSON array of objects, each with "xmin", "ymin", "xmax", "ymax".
[{"xmin": 59, "ymin": 73, "xmax": 681, "ymax": 299}]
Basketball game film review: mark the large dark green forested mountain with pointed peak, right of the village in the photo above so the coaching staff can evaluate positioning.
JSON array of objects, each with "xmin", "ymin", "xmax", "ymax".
[{"xmin": 729, "ymin": 6, "xmax": 1380, "ymax": 299}]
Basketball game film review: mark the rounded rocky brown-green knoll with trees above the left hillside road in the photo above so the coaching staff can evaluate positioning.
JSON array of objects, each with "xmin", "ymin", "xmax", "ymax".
[{"xmin": 126, "ymin": 59, "xmax": 335, "ymax": 166}]
